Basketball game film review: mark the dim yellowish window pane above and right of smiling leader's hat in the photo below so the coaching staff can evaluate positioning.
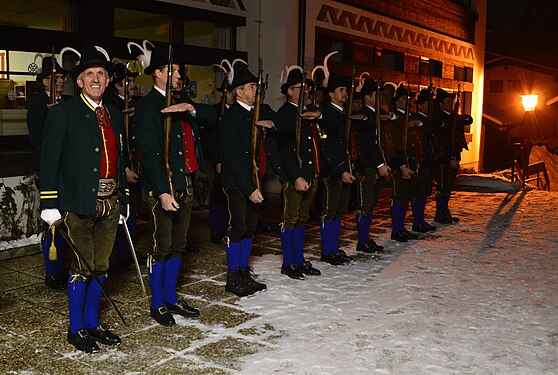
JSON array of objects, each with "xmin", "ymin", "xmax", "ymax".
[{"xmin": 114, "ymin": 8, "xmax": 170, "ymax": 43}]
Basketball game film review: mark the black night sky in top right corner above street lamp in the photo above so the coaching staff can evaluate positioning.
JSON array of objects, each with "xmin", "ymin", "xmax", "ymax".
[{"xmin": 486, "ymin": 0, "xmax": 558, "ymax": 68}]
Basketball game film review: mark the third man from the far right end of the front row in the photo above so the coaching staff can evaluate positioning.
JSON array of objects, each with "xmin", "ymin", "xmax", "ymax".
[{"xmin": 384, "ymin": 85, "xmax": 419, "ymax": 242}]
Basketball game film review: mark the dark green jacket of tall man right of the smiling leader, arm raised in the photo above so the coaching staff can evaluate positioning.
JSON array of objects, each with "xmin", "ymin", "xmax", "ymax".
[{"xmin": 134, "ymin": 89, "xmax": 217, "ymax": 196}]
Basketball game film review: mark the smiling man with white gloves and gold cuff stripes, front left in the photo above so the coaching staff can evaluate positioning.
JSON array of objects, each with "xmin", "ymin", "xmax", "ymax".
[{"xmin": 40, "ymin": 46, "xmax": 127, "ymax": 353}]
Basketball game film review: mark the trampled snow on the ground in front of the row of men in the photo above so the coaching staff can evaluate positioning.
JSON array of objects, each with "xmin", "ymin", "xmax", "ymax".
[{"xmin": 240, "ymin": 191, "xmax": 558, "ymax": 374}]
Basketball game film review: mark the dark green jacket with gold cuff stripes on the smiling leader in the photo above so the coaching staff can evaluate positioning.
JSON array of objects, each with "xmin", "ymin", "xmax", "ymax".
[{"xmin": 40, "ymin": 96, "xmax": 127, "ymax": 215}]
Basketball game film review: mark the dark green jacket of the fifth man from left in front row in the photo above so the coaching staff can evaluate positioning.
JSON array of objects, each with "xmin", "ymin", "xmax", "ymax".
[{"xmin": 319, "ymin": 103, "xmax": 349, "ymax": 176}]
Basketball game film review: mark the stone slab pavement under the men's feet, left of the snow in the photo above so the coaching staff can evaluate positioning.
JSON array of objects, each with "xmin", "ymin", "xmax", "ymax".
[{"xmin": 0, "ymin": 189, "xmax": 466, "ymax": 374}]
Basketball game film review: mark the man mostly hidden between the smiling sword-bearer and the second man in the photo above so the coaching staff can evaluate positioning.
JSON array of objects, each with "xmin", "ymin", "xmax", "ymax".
[{"xmin": 103, "ymin": 63, "xmax": 141, "ymax": 269}]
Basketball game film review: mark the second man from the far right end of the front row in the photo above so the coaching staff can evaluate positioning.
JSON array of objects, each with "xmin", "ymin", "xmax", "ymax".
[{"xmin": 411, "ymin": 89, "xmax": 438, "ymax": 233}]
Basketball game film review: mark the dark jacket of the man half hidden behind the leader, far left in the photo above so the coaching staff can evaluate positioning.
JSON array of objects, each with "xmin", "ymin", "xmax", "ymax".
[{"xmin": 27, "ymin": 91, "xmax": 72, "ymax": 171}]
